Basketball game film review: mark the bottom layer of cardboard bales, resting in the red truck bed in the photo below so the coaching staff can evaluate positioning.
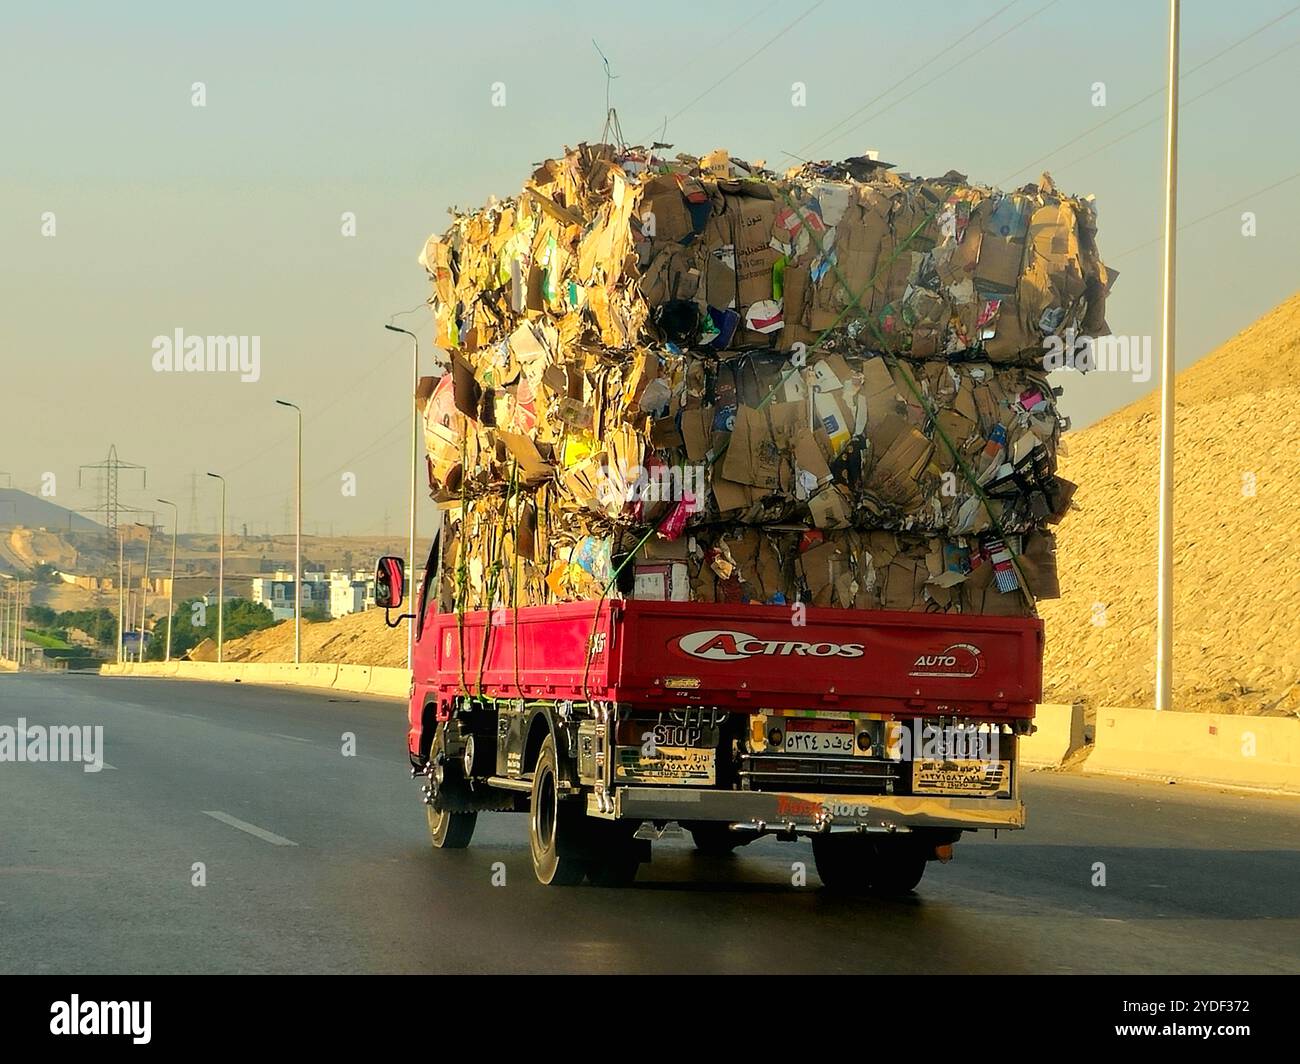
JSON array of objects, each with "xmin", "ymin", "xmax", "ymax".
[{"xmin": 441, "ymin": 486, "xmax": 1060, "ymax": 624}]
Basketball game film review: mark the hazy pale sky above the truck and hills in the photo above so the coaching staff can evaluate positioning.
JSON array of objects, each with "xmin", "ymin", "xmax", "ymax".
[{"xmin": 0, "ymin": 0, "xmax": 1300, "ymax": 533}]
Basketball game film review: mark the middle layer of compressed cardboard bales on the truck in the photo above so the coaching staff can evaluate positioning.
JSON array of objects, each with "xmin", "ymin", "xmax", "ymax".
[{"xmin": 421, "ymin": 343, "xmax": 1073, "ymax": 536}]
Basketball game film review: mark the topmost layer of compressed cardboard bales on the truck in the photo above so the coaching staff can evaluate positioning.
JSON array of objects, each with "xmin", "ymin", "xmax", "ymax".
[{"xmin": 420, "ymin": 144, "xmax": 1115, "ymax": 366}]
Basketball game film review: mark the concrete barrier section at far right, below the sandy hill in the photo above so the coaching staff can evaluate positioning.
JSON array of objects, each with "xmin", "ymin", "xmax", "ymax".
[{"xmin": 1083, "ymin": 706, "xmax": 1300, "ymax": 793}]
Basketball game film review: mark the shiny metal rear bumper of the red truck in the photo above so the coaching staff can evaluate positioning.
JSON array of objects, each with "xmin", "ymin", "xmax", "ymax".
[{"xmin": 615, "ymin": 787, "xmax": 1024, "ymax": 835}]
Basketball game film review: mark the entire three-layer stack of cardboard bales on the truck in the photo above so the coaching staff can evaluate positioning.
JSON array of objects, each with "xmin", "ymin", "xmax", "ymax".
[{"xmin": 416, "ymin": 144, "xmax": 1115, "ymax": 617}]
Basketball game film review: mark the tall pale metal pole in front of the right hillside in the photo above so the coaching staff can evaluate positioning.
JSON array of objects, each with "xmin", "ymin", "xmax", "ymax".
[{"xmin": 1156, "ymin": 0, "xmax": 1179, "ymax": 709}]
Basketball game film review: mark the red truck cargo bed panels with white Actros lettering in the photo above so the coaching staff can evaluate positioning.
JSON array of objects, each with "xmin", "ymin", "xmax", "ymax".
[{"xmin": 426, "ymin": 600, "xmax": 1043, "ymax": 721}]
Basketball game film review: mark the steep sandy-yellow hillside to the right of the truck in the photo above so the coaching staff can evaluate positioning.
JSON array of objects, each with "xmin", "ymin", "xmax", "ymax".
[{"xmin": 1041, "ymin": 294, "xmax": 1300, "ymax": 713}]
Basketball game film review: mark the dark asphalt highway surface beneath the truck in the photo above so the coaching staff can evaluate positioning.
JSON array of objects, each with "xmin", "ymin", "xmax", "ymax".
[{"xmin": 0, "ymin": 674, "xmax": 1300, "ymax": 973}]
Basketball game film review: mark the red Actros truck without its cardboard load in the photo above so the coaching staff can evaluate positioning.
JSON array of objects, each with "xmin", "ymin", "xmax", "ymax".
[{"xmin": 376, "ymin": 537, "xmax": 1043, "ymax": 894}]
